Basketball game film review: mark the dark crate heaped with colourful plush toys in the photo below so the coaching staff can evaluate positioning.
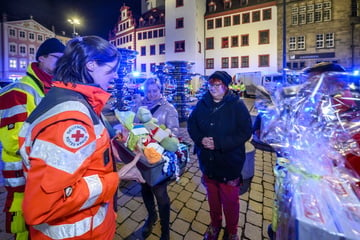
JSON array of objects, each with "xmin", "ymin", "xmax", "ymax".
[{"xmin": 112, "ymin": 107, "xmax": 190, "ymax": 186}]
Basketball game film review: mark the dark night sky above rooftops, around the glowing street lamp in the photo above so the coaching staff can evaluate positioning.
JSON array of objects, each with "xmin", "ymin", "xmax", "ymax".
[{"xmin": 0, "ymin": 0, "xmax": 140, "ymax": 39}]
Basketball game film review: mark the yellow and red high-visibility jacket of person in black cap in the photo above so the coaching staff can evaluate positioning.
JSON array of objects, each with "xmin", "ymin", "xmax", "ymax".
[{"xmin": 0, "ymin": 65, "xmax": 44, "ymax": 192}]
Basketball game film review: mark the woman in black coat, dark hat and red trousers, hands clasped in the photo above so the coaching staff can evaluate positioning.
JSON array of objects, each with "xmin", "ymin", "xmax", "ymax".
[{"xmin": 187, "ymin": 71, "xmax": 252, "ymax": 240}]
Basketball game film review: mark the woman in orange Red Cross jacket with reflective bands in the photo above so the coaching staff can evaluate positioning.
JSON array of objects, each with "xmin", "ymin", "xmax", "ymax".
[{"xmin": 20, "ymin": 36, "xmax": 120, "ymax": 240}]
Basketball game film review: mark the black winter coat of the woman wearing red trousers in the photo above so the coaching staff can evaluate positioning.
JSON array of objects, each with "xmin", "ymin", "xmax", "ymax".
[{"xmin": 187, "ymin": 91, "xmax": 252, "ymax": 182}]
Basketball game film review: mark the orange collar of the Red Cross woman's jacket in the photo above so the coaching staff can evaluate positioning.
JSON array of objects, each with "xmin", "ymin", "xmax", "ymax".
[{"xmin": 53, "ymin": 81, "xmax": 111, "ymax": 115}]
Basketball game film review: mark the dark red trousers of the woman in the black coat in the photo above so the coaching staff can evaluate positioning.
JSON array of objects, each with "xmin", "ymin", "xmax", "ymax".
[{"xmin": 202, "ymin": 175, "xmax": 240, "ymax": 234}]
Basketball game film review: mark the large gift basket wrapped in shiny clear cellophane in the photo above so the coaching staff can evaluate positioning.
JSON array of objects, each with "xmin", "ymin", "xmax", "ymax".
[{"xmin": 260, "ymin": 66, "xmax": 360, "ymax": 240}]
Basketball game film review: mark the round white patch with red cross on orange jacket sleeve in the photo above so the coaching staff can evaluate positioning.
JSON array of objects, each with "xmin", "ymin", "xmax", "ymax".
[{"xmin": 63, "ymin": 124, "xmax": 89, "ymax": 148}]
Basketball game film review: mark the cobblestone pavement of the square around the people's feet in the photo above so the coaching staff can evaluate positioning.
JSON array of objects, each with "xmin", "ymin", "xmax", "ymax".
[{"xmin": 0, "ymin": 98, "xmax": 276, "ymax": 240}]
